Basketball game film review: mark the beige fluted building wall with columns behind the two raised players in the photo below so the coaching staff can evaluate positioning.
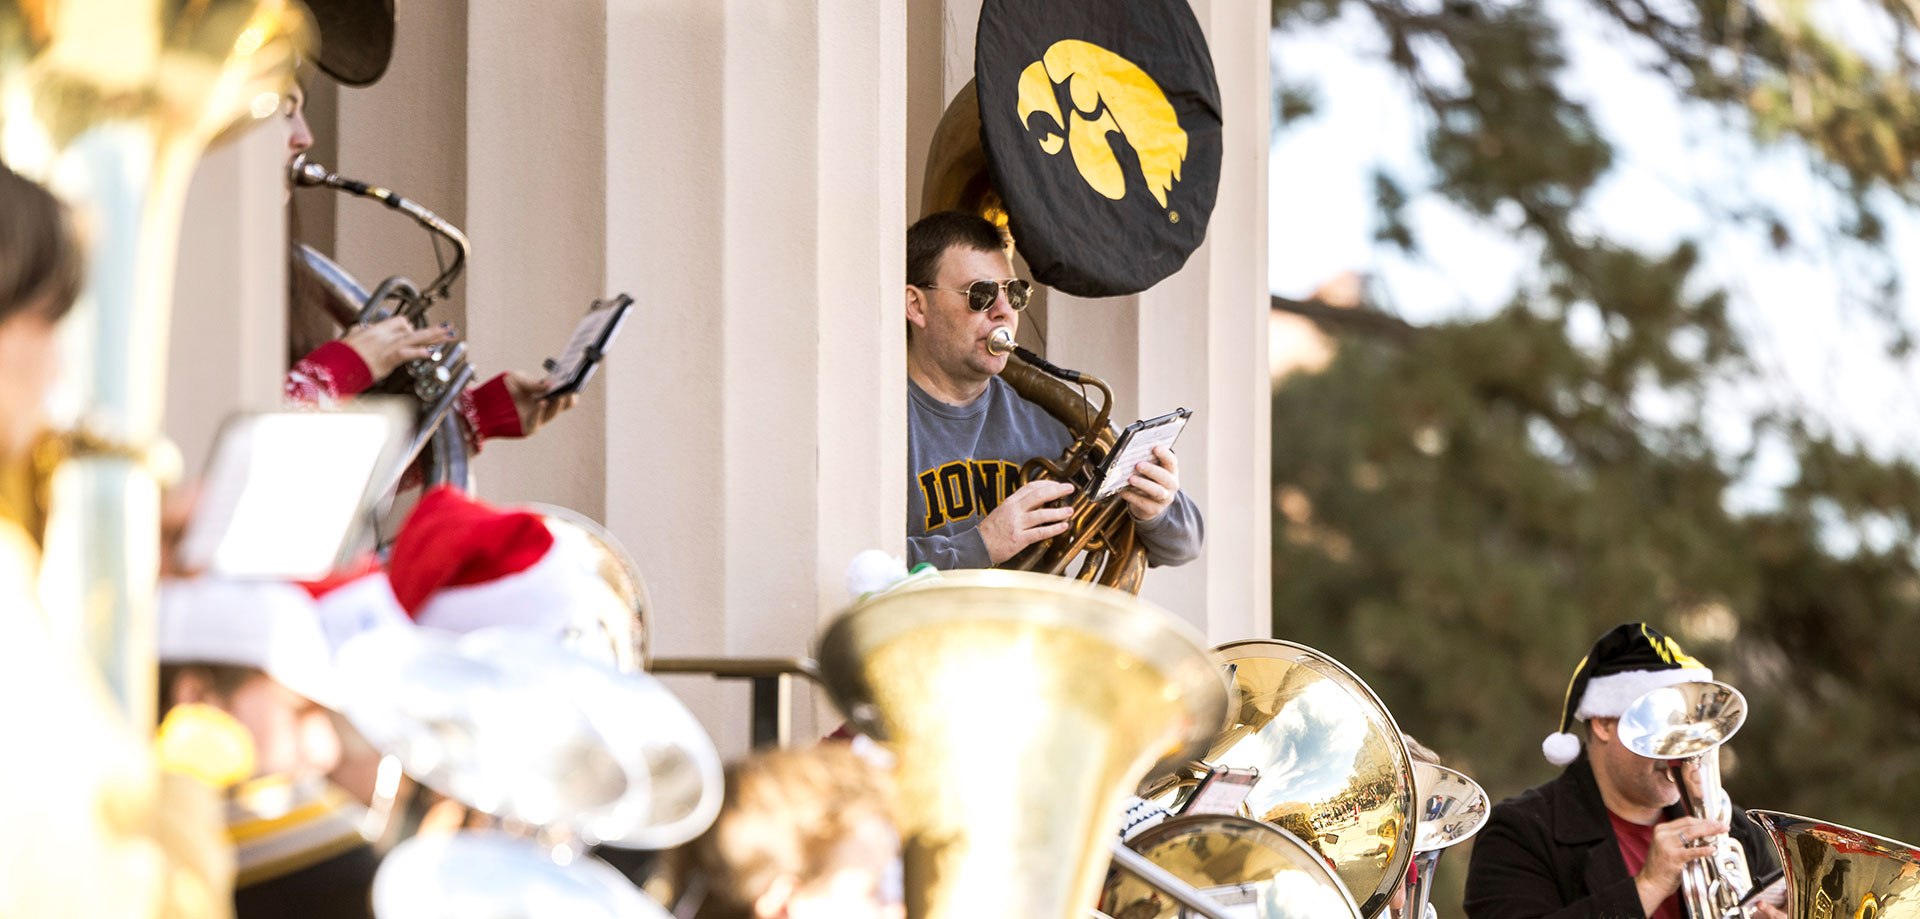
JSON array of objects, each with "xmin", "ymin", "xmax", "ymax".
[{"xmin": 175, "ymin": 0, "xmax": 1269, "ymax": 752}]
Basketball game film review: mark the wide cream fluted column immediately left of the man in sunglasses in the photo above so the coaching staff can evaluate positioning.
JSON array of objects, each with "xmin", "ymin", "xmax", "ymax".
[{"xmin": 605, "ymin": 0, "xmax": 906, "ymax": 750}]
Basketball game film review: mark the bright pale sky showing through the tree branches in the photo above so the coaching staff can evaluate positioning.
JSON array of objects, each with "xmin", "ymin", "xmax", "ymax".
[{"xmin": 1267, "ymin": 0, "xmax": 1920, "ymax": 518}]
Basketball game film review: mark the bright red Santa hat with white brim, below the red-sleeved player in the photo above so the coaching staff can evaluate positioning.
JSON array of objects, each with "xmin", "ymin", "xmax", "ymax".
[{"xmin": 388, "ymin": 487, "xmax": 622, "ymax": 639}]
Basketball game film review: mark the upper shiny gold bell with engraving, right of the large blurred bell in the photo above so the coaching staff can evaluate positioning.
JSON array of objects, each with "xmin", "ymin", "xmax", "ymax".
[{"xmin": 1140, "ymin": 639, "xmax": 1417, "ymax": 917}]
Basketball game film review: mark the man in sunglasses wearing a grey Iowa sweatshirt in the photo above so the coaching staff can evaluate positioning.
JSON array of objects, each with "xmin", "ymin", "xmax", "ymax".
[{"xmin": 906, "ymin": 211, "xmax": 1202, "ymax": 568}]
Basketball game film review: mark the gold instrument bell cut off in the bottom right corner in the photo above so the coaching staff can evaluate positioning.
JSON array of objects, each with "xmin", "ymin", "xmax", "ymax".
[{"xmin": 1747, "ymin": 810, "xmax": 1920, "ymax": 919}]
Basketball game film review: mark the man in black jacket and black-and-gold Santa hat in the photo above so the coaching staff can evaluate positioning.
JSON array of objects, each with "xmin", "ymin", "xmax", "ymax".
[{"xmin": 1465, "ymin": 622, "xmax": 1786, "ymax": 919}]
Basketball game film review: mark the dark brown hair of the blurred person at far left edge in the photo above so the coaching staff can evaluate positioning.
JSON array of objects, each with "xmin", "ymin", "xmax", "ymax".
[{"xmin": 0, "ymin": 163, "xmax": 83, "ymax": 322}]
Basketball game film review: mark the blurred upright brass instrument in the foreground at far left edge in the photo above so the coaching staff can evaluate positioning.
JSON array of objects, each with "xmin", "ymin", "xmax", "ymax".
[{"xmin": 0, "ymin": 0, "xmax": 311, "ymax": 723}]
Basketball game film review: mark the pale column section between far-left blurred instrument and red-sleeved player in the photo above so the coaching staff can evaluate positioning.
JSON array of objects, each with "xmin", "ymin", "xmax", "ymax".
[{"xmin": 163, "ymin": 121, "xmax": 286, "ymax": 478}]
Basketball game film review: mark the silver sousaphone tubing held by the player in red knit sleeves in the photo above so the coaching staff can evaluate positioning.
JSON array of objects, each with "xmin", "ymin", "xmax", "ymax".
[{"xmin": 286, "ymin": 153, "xmax": 474, "ymax": 491}]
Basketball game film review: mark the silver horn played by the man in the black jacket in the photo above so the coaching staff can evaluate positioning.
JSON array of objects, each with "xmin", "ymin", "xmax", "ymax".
[{"xmin": 1619, "ymin": 681, "xmax": 1753, "ymax": 919}]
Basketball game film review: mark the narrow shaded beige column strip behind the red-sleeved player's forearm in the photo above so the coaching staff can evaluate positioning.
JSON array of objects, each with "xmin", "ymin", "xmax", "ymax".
[{"xmin": 467, "ymin": 0, "xmax": 602, "ymax": 518}]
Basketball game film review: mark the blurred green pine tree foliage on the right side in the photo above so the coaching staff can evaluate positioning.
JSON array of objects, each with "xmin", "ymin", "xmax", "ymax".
[{"xmin": 1273, "ymin": 0, "xmax": 1920, "ymax": 915}]
